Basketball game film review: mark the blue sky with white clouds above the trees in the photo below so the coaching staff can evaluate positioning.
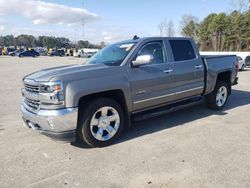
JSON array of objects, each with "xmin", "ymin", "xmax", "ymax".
[{"xmin": 0, "ymin": 0, "xmax": 244, "ymax": 43}]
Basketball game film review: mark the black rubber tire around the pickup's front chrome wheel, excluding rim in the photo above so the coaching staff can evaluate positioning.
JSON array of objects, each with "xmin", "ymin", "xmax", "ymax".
[{"xmin": 78, "ymin": 98, "xmax": 125, "ymax": 147}]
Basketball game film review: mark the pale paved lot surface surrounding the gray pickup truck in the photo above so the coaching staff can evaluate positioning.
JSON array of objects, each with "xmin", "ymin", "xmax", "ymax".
[{"xmin": 0, "ymin": 56, "xmax": 250, "ymax": 188}]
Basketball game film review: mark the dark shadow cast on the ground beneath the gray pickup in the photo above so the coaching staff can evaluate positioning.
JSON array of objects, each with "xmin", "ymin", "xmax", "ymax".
[{"xmin": 71, "ymin": 90, "xmax": 250, "ymax": 149}]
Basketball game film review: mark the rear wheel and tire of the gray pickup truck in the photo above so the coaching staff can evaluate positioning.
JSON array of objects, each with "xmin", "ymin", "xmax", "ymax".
[{"xmin": 205, "ymin": 81, "xmax": 229, "ymax": 110}]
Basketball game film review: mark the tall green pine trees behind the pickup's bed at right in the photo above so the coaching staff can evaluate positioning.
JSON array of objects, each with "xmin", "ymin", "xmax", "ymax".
[{"xmin": 181, "ymin": 9, "xmax": 250, "ymax": 51}]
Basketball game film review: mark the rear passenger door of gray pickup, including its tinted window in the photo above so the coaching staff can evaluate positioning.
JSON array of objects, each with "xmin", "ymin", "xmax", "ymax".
[{"xmin": 169, "ymin": 39, "xmax": 204, "ymax": 100}]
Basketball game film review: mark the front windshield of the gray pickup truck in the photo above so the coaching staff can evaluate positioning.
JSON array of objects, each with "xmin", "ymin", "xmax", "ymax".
[{"xmin": 87, "ymin": 42, "xmax": 135, "ymax": 66}]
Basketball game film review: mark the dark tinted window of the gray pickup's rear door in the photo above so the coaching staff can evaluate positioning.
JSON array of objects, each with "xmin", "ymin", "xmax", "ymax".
[{"xmin": 169, "ymin": 40, "xmax": 196, "ymax": 61}]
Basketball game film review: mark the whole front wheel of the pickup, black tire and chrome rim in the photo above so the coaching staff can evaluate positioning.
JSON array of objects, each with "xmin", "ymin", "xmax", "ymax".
[{"xmin": 77, "ymin": 98, "xmax": 125, "ymax": 147}]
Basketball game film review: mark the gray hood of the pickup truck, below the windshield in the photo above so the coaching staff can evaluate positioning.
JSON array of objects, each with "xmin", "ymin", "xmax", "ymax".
[{"xmin": 24, "ymin": 65, "xmax": 108, "ymax": 82}]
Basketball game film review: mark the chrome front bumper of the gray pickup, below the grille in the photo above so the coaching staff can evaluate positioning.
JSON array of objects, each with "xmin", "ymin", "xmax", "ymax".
[{"xmin": 21, "ymin": 103, "xmax": 78, "ymax": 142}]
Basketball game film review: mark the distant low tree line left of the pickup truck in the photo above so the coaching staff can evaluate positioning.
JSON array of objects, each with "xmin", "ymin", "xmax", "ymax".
[{"xmin": 0, "ymin": 34, "xmax": 105, "ymax": 48}]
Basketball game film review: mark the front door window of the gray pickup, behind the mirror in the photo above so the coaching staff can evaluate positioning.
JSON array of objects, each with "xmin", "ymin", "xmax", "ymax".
[{"xmin": 137, "ymin": 42, "xmax": 165, "ymax": 64}]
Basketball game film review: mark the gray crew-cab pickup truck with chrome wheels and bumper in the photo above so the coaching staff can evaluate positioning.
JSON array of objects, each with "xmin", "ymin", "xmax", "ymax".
[{"xmin": 21, "ymin": 37, "xmax": 238, "ymax": 147}]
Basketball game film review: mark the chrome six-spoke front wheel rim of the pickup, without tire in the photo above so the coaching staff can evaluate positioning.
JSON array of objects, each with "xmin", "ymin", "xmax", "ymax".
[{"xmin": 90, "ymin": 106, "xmax": 120, "ymax": 141}]
